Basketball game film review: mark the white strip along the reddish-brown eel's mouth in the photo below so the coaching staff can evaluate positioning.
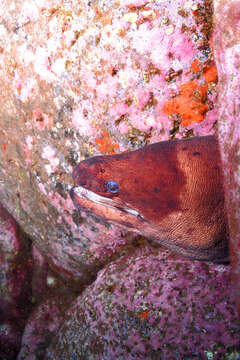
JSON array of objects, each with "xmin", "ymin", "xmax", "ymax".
[{"xmin": 73, "ymin": 186, "xmax": 144, "ymax": 220}]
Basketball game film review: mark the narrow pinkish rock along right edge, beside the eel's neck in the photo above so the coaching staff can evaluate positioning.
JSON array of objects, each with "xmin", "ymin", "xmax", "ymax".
[{"xmin": 214, "ymin": 1, "xmax": 240, "ymax": 318}]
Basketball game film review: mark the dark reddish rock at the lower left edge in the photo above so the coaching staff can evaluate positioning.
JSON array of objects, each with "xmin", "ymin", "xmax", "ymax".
[{"xmin": 0, "ymin": 204, "xmax": 33, "ymax": 360}]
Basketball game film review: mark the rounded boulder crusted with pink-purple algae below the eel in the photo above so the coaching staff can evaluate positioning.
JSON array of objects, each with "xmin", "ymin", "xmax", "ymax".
[{"xmin": 45, "ymin": 248, "xmax": 240, "ymax": 360}]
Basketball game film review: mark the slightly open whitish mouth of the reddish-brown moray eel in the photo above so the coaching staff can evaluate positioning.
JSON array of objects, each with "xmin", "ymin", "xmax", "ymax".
[{"xmin": 70, "ymin": 186, "xmax": 146, "ymax": 221}]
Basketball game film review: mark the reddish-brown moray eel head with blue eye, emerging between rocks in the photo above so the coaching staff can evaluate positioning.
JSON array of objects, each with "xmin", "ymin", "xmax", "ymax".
[{"xmin": 70, "ymin": 136, "xmax": 228, "ymax": 262}]
